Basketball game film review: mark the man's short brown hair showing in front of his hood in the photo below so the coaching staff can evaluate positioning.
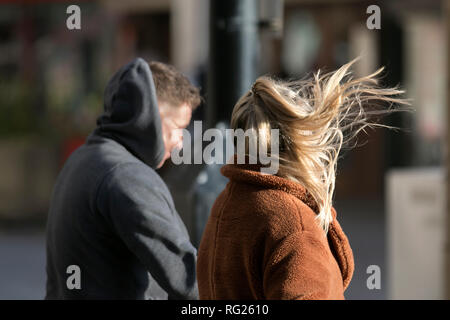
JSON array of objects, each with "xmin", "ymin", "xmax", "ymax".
[{"xmin": 150, "ymin": 61, "xmax": 201, "ymax": 109}]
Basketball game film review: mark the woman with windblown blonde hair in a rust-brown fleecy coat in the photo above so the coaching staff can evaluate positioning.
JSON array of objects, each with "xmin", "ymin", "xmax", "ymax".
[{"xmin": 197, "ymin": 61, "xmax": 406, "ymax": 300}]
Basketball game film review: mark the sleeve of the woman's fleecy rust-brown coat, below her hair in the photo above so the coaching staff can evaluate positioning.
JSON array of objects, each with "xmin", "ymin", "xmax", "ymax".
[{"xmin": 263, "ymin": 231, "xmax": 336, "ymax": 300}]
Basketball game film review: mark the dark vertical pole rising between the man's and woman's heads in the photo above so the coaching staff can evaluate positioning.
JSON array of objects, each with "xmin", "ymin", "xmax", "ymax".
[{"xmin": 207, "ymin": 0, "xmax": 260, "ymax": 127}]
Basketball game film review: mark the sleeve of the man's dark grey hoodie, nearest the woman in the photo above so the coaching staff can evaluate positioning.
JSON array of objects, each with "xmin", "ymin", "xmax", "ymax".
[{"xmin": 97, "ymin": 164, "xmax": 198, "ymax": 299}]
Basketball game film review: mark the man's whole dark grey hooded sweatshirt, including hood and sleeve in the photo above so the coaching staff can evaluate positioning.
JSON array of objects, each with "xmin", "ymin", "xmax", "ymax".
[{"xmin": 45, "ymin": 58, "xmax": 198, "ymax": 299}]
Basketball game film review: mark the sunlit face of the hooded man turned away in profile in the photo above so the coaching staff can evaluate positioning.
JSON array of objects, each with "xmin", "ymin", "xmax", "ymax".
[{"xmin": 158, "ymin": 102, "xmax": 192, "ymax": 168}]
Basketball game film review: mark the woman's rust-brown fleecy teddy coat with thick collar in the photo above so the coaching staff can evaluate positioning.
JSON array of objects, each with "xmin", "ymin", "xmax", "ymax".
[{"xmin": 197, "ymin": 164, "xmax": 354, "ymax": 300}]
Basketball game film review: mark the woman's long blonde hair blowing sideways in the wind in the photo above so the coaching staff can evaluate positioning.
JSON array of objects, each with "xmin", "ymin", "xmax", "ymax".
[{"xmin": 231, "ymin": 59, "xmax": 408, "ymax": 233}]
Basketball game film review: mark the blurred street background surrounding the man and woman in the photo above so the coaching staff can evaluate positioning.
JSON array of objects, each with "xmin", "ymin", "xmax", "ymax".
[{"xmin": 0, "ymin": 0, "xmax": 450, "ymax": 299}]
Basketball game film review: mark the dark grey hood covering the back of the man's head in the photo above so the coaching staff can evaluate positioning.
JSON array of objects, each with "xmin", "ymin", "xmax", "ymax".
[{"xmin": 94, "ymin": 58, "xmax": 165, "ymax": 168}]
